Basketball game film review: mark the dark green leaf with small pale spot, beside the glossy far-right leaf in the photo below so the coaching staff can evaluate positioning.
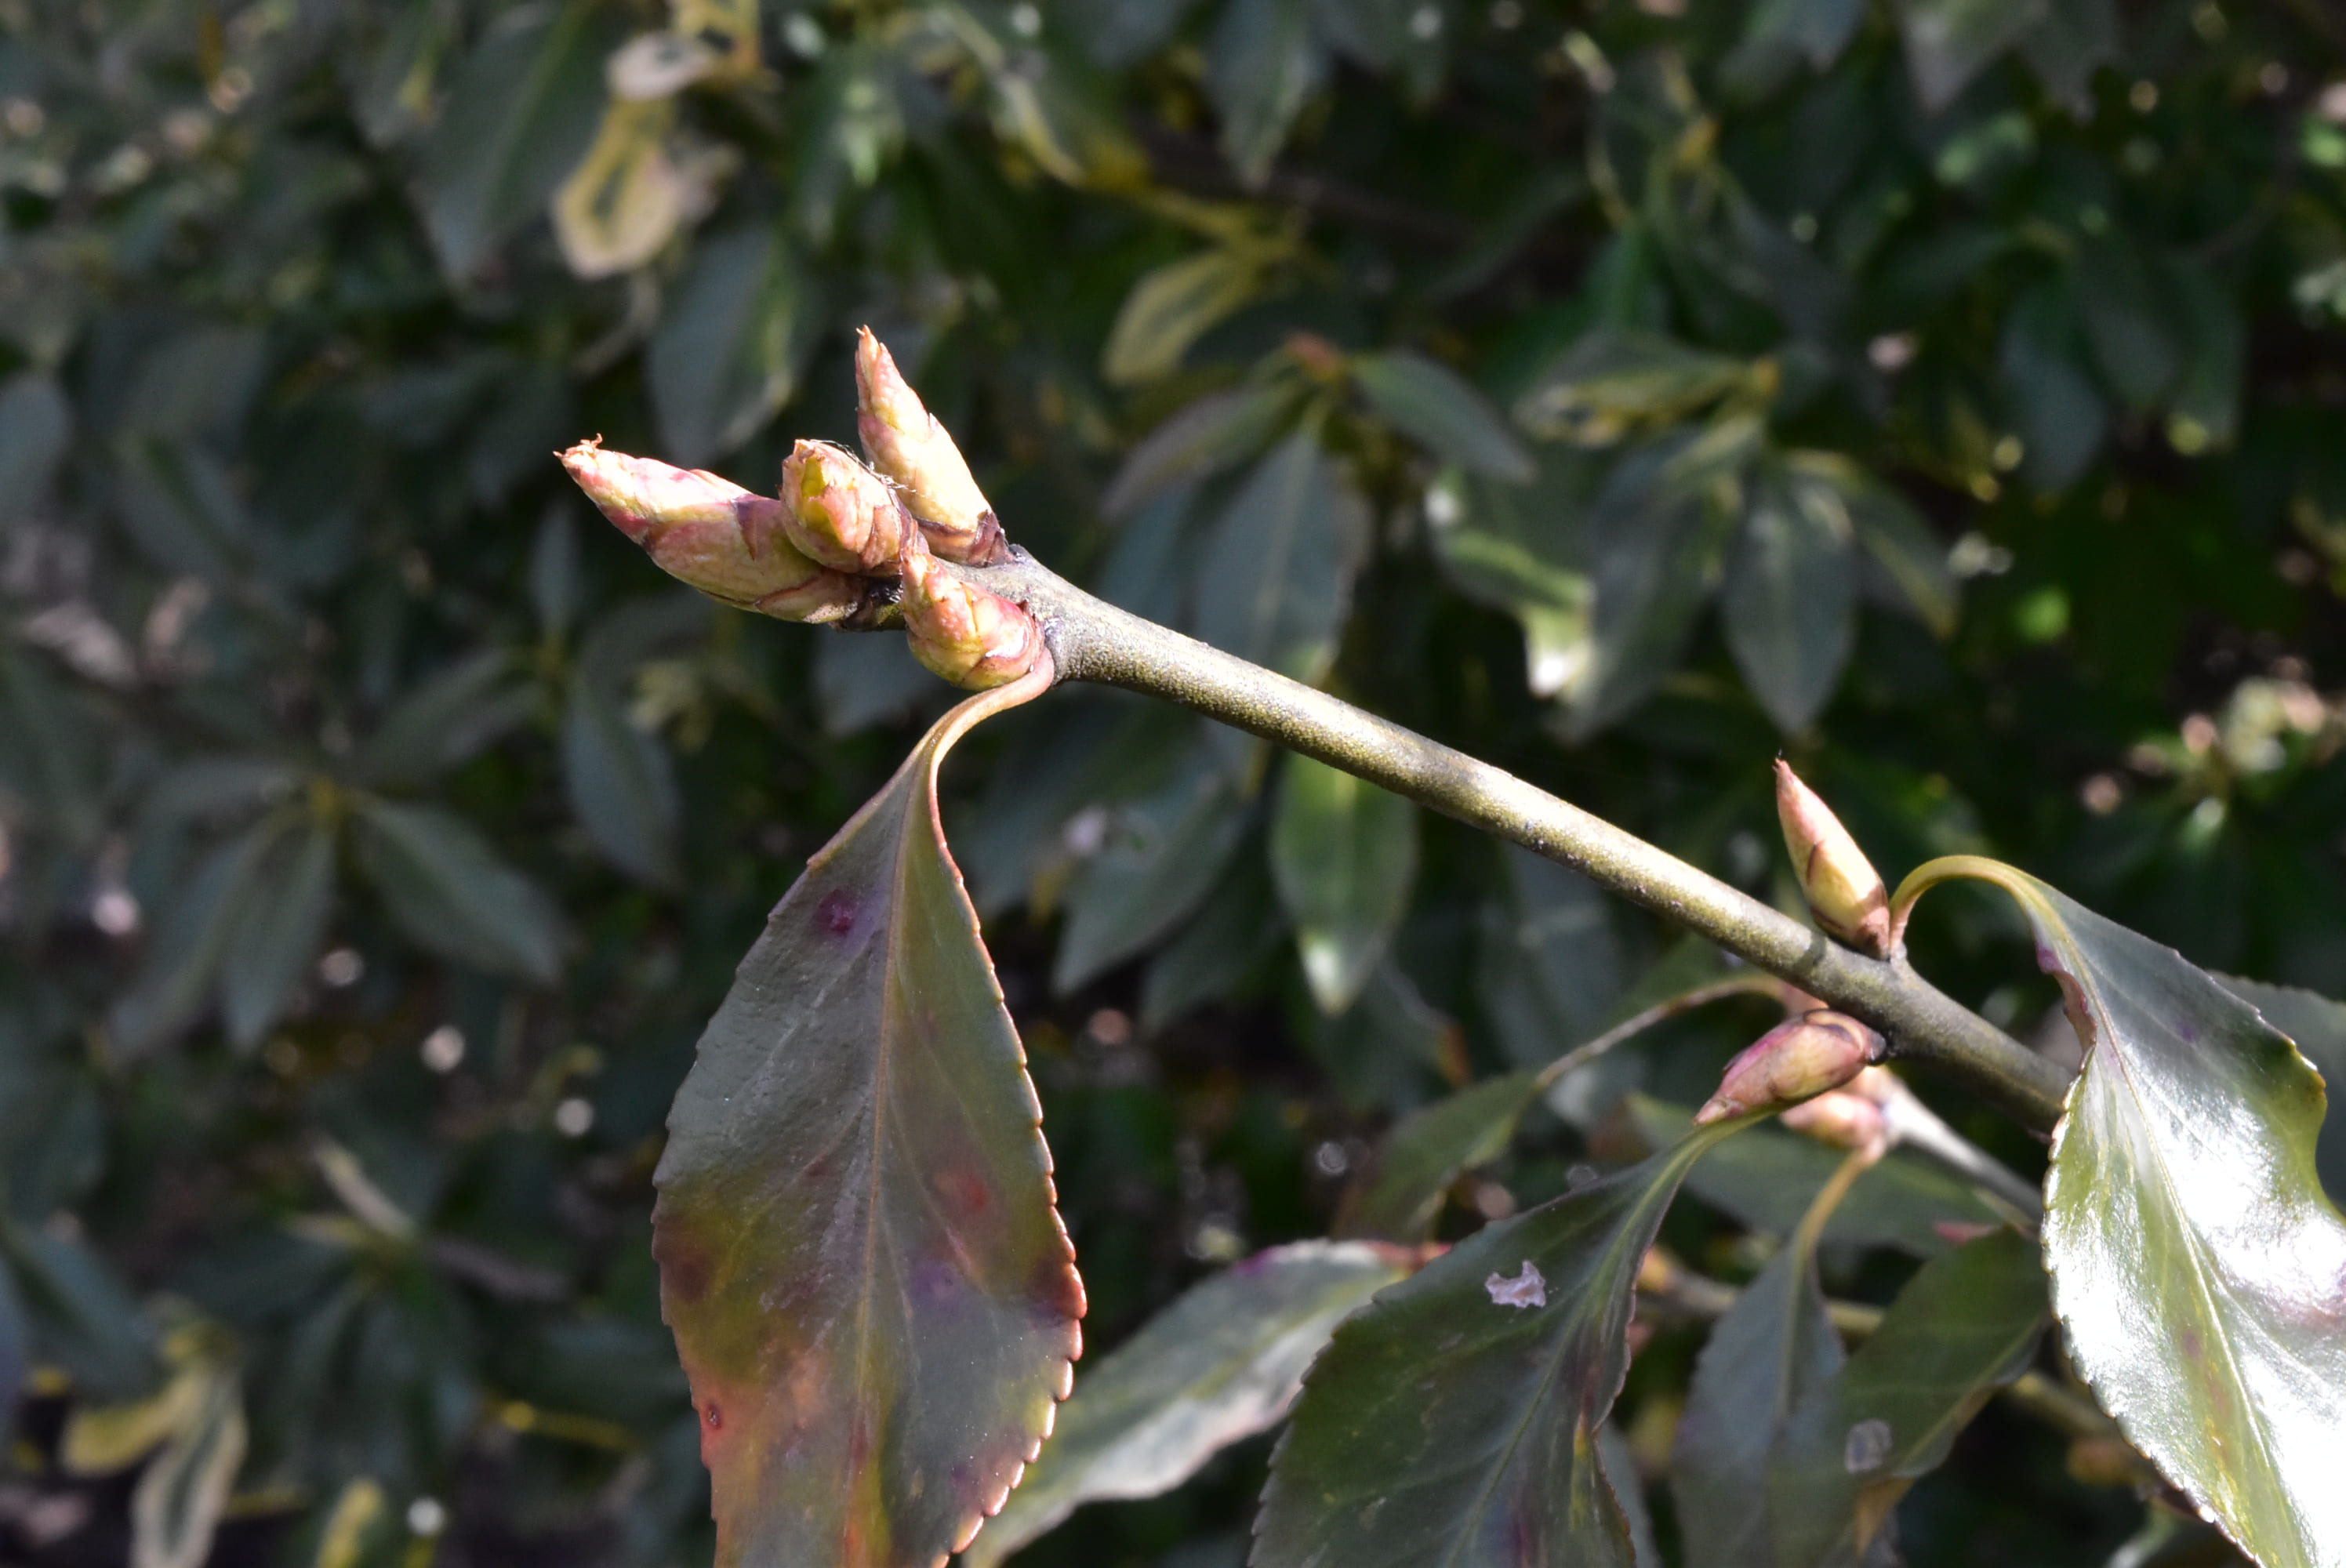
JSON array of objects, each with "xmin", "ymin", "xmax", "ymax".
[{"xmin": 1743, "ymin": 1230, "xmax": 2046, "ymax": 1568}]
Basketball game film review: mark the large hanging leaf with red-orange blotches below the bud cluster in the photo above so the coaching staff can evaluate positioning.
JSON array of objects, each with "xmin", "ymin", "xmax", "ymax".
[{"xmin": 652, "ymin": 683, "xmax": 1084, "ymax": 1568}]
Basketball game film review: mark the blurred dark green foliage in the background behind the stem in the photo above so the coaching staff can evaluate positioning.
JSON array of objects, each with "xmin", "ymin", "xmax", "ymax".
[{"xmin": 0, "ymin": 0, "xmax": 2346, "ymax": 1568}]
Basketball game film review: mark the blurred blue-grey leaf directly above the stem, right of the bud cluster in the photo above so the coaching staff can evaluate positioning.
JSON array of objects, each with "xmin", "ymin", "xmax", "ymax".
[{"xmin": 1197, "ymin": 430, "xmax": 1367, "ymax": 683}]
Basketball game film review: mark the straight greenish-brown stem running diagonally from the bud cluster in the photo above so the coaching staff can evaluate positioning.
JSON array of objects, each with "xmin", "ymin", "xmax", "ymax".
[{"xmin": 955, "ymin": 552, "xmax": 2067, "ymax": 1129}]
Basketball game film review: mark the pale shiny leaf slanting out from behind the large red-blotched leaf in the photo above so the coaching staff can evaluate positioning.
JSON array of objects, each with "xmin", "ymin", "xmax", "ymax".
[{"xmin": 960, "ymin": 1242, "xmax": 1414, "ymax": 1568}]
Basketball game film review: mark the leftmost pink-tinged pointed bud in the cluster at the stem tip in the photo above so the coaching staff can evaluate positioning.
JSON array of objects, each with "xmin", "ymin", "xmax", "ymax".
[{"xmin": 561, "ymin": 441, "xmax": 873, "ymax": 622}]
